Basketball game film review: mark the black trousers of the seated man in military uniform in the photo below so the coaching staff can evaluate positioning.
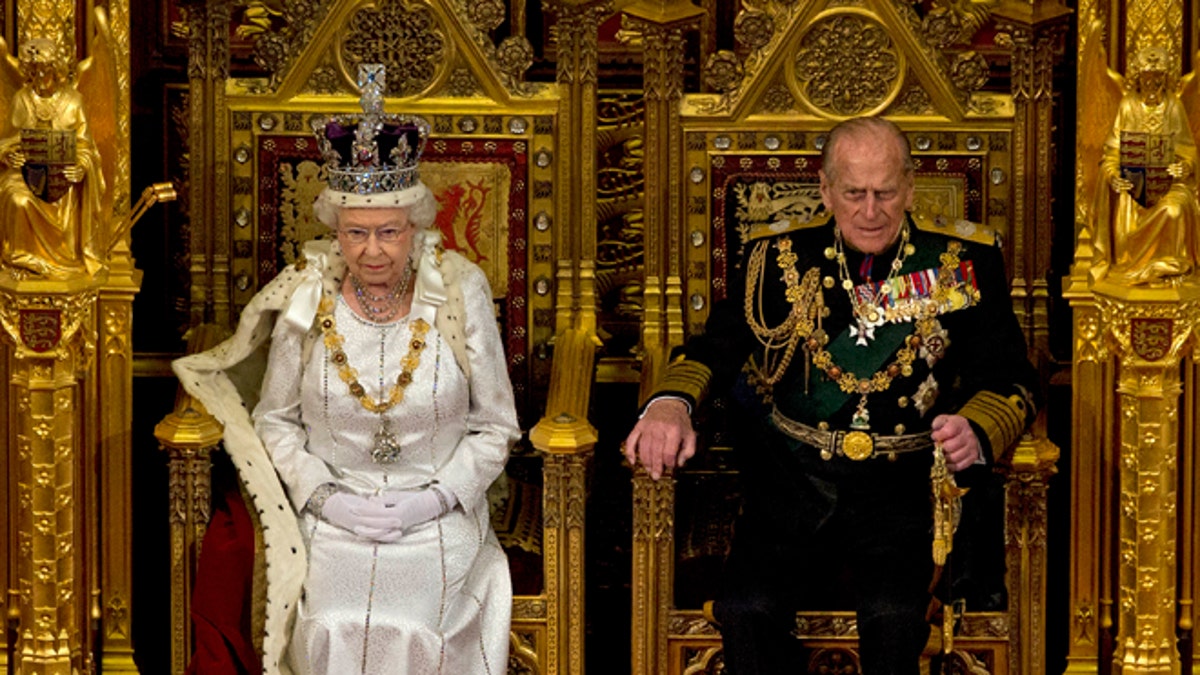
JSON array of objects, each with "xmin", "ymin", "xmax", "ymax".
[{"xmin": 714, "ymin": 432, "xmax": 934, "ymax": 675}]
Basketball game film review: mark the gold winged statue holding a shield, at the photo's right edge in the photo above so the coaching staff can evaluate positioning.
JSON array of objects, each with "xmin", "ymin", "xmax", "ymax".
[{"xmin": 1080, "ymin": 28, "xmax": 1200, "ymax": 285}]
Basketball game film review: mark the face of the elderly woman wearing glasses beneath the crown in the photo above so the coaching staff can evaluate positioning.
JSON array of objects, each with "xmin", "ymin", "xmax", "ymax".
[{"xmin": 337, "ymin": 208, "xmax": 416, "ymax": 289}]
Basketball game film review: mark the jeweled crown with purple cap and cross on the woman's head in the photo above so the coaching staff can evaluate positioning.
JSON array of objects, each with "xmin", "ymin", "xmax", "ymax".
[{"xmin": 312, "ymin": 64, "xmax": 430, "ymax": 195}]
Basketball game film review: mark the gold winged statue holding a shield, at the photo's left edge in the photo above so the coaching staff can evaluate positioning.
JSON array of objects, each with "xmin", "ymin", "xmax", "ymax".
[{"xmin": 0, "ymin": 27, "xmax": 116, "ymax": 279}]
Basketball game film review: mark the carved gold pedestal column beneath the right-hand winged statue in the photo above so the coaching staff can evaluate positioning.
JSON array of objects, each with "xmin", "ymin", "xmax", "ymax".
[{"xmin": 1094, "ymin": 283, "xmax": 1200, "ymax": 675}]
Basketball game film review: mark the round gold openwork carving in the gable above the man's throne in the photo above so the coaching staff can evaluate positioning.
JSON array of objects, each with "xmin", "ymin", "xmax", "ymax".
[{"xmin": 793, "ymin": 12, "xmax": 905, "ymax": 117}]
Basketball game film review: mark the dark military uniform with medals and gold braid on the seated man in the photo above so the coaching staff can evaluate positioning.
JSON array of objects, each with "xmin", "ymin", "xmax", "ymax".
[{"xmin": 656, "ymin": 217, "xmax": 1037, "ymax": 675}]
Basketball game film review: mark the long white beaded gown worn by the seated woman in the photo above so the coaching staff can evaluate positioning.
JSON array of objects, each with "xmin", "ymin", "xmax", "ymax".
[{"xmin": 254, "ymin": 268, "xmax": 520, "ymax": 675}]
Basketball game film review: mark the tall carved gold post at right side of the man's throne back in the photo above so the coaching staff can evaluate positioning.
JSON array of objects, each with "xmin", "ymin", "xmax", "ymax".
[{"xmin": 995, "ymin": 0, "xmax": 1070, "ymax": 363}]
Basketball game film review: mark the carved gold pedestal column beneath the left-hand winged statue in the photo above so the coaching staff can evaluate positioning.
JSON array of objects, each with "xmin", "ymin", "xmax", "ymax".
[{"xmin": 0, "ymin": 280, "xmax": 96, "ymax": 675}]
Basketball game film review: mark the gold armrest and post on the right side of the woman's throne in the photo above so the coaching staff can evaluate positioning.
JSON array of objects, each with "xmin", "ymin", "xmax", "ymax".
[{"xmin": 529, "ymin": 328, "xmax": 596, "ymax": 675}]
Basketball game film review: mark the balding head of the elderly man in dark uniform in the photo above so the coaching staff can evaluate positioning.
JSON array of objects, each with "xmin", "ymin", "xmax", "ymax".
[{"xmin": 821, "ymin": 131, "xmax": 913, "ymax": 253}]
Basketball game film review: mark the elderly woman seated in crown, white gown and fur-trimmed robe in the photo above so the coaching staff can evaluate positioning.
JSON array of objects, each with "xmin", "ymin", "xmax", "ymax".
[{"xmin": 176, "ymin": 69, "xmax": 518, "ymax": 675}]
